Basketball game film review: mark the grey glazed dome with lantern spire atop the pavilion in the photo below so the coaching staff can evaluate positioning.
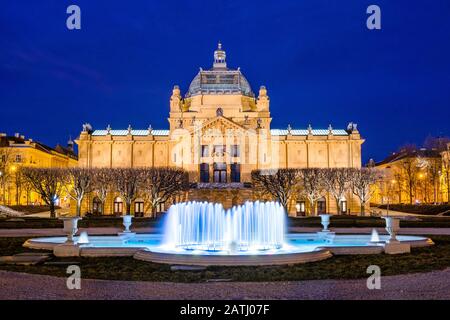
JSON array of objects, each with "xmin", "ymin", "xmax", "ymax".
[{"xmin": 186, "ymin": 43, "xmax": 255, "ymax": 97}]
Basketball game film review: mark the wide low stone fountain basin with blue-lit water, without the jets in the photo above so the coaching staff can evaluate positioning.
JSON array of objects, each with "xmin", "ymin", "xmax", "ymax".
[{"xmin": 24, "ymin": 233, "xmax": 433, "ymax": 266}]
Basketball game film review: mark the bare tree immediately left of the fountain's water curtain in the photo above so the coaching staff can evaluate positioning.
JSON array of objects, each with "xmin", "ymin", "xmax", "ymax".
[{"xmin": 142, "ymin": 167, "xmax": 189, "ymax": 216}]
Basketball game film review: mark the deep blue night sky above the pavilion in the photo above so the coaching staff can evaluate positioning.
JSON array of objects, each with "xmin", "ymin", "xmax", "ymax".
[{"xmin": 0, "ymin": 0, "xmax": 450, "ymax": 161}]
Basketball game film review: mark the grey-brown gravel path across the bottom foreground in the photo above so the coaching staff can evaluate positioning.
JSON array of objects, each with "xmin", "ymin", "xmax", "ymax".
[{"xmin": 0, "ymin": 268, "xmax": 450, "ymax": 300}]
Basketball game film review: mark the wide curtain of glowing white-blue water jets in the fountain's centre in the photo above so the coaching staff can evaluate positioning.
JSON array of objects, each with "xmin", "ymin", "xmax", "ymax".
[{"xmin": 162, "ymin": 201, "xmax": 285, "ymax": 251}]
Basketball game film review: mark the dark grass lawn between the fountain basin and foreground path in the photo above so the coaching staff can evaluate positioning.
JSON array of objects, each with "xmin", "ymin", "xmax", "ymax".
[{"xmin": 0, "ymin": 236, "xmax": 450, "ymax": 282}]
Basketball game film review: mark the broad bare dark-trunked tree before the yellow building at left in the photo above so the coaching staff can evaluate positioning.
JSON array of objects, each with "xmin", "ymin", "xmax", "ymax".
[{"xmin": 22, "ymin": 167, "xmax": 64, "ymax": 218}]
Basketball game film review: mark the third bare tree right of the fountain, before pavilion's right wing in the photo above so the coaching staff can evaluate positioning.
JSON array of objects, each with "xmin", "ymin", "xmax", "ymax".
[{"xmin": 323, "ymin": 168, "xmax": 352, "ymax": 214}]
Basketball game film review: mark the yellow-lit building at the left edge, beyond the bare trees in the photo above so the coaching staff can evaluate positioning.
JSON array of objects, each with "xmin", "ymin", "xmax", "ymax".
[{"xmin": 0, "ymin": 133, "xmax": 78, "ymax": 205}]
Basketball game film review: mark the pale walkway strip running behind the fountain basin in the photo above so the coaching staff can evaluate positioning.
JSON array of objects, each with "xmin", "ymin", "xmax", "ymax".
[{"xmin": 0, "ymin": 227, "xmax": 450, "ymax": 237}]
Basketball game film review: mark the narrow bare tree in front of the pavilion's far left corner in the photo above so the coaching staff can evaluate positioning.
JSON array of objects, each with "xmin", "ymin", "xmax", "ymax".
[{"xmin": 62, "ymin": 167, "xmax": 92, "ymax": 217}]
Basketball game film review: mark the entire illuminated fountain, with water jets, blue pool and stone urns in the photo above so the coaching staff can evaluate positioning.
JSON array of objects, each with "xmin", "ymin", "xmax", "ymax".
[{"xmin": 24, "ymin": 201, "xmax": 433, "ymax": 266}]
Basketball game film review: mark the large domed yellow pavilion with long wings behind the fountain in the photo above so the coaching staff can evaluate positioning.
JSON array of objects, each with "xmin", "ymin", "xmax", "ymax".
[{"xmin": 76, "ymin": 43, "xmax": 364, "ymax": 214}]
